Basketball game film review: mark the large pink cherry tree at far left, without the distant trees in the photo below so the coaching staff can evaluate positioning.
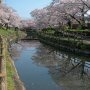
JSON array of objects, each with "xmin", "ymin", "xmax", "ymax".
[{"xmin": 0, "ymin": 4, "xmax": 21, "ymax": 27}]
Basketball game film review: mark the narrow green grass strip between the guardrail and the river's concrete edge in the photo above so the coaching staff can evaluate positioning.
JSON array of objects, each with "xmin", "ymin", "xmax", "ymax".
[{"xmin": 2, "ymin": 39, "xmax": 15, "ymax": 90}]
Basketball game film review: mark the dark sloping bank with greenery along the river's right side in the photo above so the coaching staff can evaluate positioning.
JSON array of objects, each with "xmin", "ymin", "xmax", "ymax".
[{"xmin": 38, "ymin": 32, "xmax": 90, "ymax": 56}]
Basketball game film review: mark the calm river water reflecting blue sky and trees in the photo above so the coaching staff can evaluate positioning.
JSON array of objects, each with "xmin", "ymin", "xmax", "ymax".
[{"xmin": 11, "ymin": 41, "xmax": 90, "ymax": 90}]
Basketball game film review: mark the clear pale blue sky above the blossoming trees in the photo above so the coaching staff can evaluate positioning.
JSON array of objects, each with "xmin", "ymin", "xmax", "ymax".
[{"xmin": 4, "ymin": 0, "xmax": 52, "ymax": 18}]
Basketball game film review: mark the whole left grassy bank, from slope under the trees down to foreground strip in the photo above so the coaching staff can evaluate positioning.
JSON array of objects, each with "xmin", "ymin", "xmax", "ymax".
[{"xmin": 0, "ymin": 29, "xmax": 25, "ymax": 90}]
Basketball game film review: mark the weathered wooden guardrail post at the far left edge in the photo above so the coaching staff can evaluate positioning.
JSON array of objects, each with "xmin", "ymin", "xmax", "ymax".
[{"xmin": 0, "ymin": 36, "xmax": 7, "ymax": 90}]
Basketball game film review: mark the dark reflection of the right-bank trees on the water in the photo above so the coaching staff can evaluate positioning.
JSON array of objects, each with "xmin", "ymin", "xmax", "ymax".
[{"xmin": 33, "ymin": 45, "xmax": 90, "ymax": 90}]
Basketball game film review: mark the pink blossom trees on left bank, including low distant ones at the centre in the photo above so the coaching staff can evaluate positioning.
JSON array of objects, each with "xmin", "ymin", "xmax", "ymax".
[{"xmin": 0, "ymin": 4, "xmax": 35, "ymax": 28}]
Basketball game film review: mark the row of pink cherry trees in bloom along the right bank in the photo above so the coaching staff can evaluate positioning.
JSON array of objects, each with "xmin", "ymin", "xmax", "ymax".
[{"xmin": 31, "ymin": 0, "xmax": 90, "ymax": 29}]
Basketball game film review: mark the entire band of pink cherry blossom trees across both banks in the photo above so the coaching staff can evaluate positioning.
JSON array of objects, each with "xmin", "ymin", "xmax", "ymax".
[{"xmin": 0, "ymin": 0, "xmax": 90, "ymax": 29}]
